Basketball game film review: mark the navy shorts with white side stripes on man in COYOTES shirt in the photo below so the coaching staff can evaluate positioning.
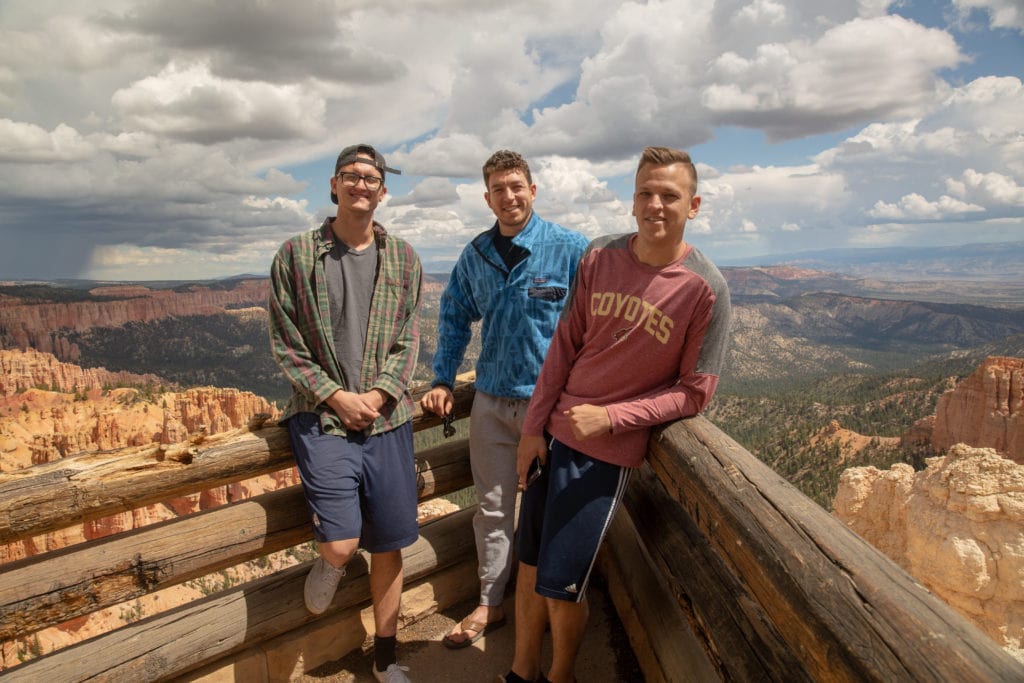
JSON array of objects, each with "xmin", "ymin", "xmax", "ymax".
[{"xmin": 516, "ymin": 439, "xmax": 633, "ymax": 602}]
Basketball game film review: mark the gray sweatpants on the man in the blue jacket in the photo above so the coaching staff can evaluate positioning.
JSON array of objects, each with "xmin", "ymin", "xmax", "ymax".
[{"xmin": 469, "ymin": 391, "xmax": 529, "ymax": 605}]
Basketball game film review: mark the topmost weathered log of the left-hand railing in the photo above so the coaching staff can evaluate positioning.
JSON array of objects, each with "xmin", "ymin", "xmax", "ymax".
[{"xmin": 0, "ymin": 384, "xmax": 472, "ymax": 544}]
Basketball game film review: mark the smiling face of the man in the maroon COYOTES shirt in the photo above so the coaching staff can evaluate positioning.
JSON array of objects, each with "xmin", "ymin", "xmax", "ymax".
[{"xmin": 633, "ymin": 164, "xmax": 700, "ymax": 258}]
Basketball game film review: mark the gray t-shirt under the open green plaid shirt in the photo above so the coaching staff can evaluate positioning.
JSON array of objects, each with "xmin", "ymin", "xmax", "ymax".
[{"xmin": 324, "ymin": 240, "xmax": 377, "ymax": 393}]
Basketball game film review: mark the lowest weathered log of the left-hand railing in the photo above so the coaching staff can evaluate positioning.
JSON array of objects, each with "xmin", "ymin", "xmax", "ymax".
[{"xmin": 4, "ymin": 510, "xmax": 475, "ymax": 683}]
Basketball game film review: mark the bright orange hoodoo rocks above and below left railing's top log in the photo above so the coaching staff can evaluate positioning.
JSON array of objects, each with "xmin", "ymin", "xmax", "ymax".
[{"xmin": 0, "ymin": 350, "xmax": 288, "ymax": 562}]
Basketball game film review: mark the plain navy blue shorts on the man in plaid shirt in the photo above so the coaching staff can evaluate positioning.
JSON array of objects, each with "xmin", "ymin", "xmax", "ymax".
[{"xmin": 288, "ymin": 413, "xmax": 420, "ymax": 553}]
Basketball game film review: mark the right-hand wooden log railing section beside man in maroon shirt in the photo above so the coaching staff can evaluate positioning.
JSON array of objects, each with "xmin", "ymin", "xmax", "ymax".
[{"xmin": 602, "ymin": 417, "xmax": 1024, "ymax": 682}]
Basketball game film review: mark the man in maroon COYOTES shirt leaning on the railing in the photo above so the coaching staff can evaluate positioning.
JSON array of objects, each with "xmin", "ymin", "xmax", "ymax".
[{"xmin": 501, "ymin": 147, "xmax": 731, "ymax": 683}]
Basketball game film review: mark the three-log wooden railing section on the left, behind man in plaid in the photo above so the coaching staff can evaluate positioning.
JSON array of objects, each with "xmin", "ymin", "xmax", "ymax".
[{"xmin": 0, "ymin": 382, "xmax": 475, "ymax": 681}]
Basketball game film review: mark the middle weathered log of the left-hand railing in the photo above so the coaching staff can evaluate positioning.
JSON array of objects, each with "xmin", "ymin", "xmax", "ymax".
[{"xmin": 0, "ymin": 439, "xmax": 472, "ymax": 640}]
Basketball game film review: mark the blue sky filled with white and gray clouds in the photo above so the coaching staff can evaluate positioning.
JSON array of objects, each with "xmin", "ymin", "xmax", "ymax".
[{"xmin": 0, "ymin": 0, "xmax": 1024, "ymax": 280}]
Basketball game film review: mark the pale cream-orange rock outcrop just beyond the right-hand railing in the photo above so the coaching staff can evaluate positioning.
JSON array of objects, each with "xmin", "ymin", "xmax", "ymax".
[{"xmin": 834, "ymin": 443, "xmax": 1024, "ymax": 661}]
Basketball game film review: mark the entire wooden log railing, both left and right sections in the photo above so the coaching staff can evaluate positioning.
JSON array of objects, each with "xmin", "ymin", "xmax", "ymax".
[{"xmin": 0, "ymin": 387, "xmax": 1024, "ymax": 682}]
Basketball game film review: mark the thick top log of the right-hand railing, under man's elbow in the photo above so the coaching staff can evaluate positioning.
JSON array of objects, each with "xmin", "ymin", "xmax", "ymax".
[{"xmin": 649, "ymin": 417, "xmax": 1022, "ymax": 681}]
